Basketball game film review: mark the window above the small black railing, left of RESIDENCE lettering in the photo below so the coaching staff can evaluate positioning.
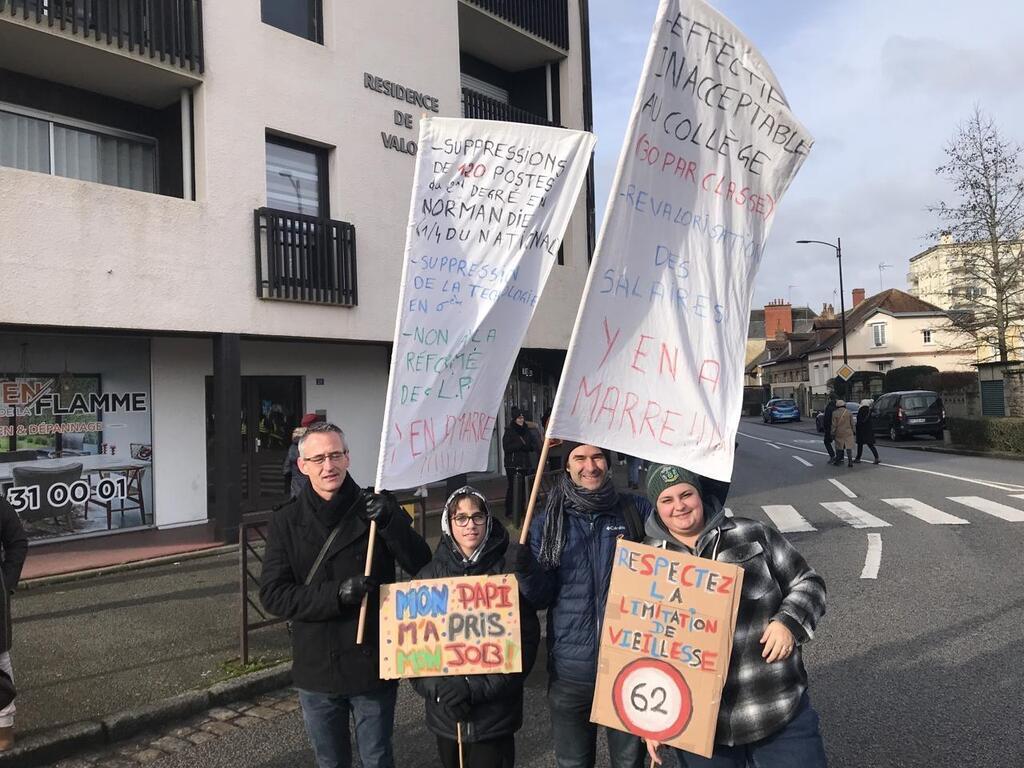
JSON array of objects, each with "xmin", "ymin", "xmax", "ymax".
[{"xmin": 266, "ymin": 136, "xmax": 331, "ymax": 218}]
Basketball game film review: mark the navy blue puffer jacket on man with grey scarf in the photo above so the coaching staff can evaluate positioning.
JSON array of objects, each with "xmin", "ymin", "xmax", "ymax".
[{"xmin": 519, "ymin": 494, "xmax": 652, "ymax": 683}]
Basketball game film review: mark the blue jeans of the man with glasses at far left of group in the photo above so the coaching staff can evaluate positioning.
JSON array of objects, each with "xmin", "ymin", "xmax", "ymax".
[{"xmin": 299, "ymin": 685, "xmax": 398, "ymax": 768}]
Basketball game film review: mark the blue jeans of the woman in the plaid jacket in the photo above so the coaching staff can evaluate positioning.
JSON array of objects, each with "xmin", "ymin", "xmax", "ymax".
[{"xmin": 673, "ymin": 693, "xmax": 827, "ymax": 768}]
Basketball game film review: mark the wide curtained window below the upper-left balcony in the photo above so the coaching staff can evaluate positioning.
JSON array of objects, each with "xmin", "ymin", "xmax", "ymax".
[{"xmin": 0, "ymin": 106, "xmax": 157, "ymax": 193}]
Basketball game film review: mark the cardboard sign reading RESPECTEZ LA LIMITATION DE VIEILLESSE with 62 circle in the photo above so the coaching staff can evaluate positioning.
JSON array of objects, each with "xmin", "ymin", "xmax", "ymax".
[{"xmin": 590, "ymin": 540, "xmax": 743, "ymax": 757}]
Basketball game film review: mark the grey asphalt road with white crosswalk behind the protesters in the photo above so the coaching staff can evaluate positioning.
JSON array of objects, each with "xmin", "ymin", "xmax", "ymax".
[{"xmin": 75, "ymin": 430, "xmax": 1024, "ymax": 768}]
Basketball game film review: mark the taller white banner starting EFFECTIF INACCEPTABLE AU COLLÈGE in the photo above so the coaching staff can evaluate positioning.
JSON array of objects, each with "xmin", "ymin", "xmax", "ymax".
[{"xmin": 549, "ymin": 0, "xmax": 813, "ymax": 480}]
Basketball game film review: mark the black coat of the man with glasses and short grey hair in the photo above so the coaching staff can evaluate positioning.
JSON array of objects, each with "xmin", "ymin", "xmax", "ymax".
[{"xmin": 259, "ymin": 475, "xmax": 430, "ymax": 695}]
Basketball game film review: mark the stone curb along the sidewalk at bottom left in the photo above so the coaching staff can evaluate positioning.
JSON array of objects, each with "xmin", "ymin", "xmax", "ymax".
[{"xmin": 0, "ymin": 662, "xmax": 292, "ymax": 768}]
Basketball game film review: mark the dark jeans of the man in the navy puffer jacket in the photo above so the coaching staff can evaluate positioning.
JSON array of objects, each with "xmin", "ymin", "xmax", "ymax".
[{"xmin": 548, "ymin": 680, "xmax": 647, "ymax": 768}]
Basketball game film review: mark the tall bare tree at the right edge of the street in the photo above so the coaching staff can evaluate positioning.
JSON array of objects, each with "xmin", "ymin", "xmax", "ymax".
[{"xmin": 929, "ymin": 109, "xmax": 1024, "ymax": 362}]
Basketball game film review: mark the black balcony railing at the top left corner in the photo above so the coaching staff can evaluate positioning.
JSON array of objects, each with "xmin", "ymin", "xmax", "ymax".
[{"xmin": 0, "ymin": 0, "xmax": 203, "ymax": 72}]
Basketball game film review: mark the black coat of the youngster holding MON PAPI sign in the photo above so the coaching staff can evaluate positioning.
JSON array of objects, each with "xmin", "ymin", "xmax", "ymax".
[{"xmin": 410, "ymin": 520, "xmax": 541, "ymax": 741}]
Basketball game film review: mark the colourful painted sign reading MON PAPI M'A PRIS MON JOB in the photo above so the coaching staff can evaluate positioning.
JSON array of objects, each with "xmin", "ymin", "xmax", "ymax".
[{"xmin": 380, "ymin": 573, "xmax": 522, "ymax": 680}]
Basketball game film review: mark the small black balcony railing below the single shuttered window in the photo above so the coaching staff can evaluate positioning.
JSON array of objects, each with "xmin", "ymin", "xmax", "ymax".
[{"xmin": 254, "ymin": 208, "xmax": 358, "ymax": 306}]
